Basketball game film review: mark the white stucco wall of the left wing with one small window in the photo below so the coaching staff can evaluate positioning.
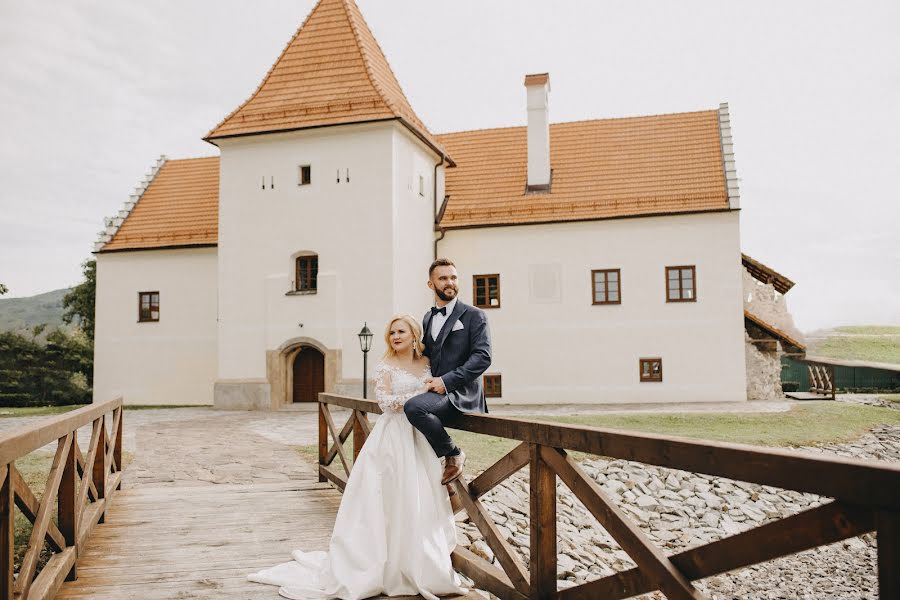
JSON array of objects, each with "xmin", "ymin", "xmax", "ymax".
[{"xmin": 94, "ymin": 248, "xmax": 216, "ymax": 404}]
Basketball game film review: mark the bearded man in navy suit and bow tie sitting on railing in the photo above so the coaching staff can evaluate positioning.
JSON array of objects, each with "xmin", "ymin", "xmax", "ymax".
[{"xmin": 403, "ymin": 258, "xmax": 491, "ymax": 485}]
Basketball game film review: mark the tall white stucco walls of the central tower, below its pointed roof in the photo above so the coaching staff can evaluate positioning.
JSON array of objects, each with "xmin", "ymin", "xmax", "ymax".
[{"xmin": 218, "ymin": 122, "xmax": 435, "ymax": 381}]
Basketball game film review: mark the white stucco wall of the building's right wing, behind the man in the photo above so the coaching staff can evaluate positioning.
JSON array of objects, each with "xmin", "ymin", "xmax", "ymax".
[{"xmin": 438, "ymin": 212, "xmax": 746, "ymax": 404}]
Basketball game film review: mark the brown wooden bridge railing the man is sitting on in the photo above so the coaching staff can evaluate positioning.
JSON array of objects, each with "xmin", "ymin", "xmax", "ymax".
[{"xmin": 319, "ymin": 394, "xmax": 900, "ymax": 600}]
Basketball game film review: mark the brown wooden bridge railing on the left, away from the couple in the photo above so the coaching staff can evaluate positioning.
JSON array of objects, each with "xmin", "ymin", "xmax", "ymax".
[{"xmin": 0, "ymin": 398, "xmax": 122, "ymax": 600}]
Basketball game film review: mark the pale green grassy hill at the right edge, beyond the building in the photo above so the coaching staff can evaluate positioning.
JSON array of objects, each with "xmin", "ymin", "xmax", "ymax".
[{"xmin": 806, "ymin": 325, "xmax": 900, "ymax": 364}]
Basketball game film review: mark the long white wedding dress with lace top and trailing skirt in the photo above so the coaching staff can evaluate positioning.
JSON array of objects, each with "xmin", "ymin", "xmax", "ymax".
[{"xmin": 248, "ymin": 362, "xmax": 467, "ymax": 600}]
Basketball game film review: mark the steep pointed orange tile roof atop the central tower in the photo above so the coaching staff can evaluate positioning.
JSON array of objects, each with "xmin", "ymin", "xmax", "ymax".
[{"xmin": 204, "ymin": 0, "xmax": 452, "ymax": 164}]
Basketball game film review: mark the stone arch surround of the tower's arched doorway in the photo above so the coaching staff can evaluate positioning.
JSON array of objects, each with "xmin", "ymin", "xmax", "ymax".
[{"xmin": 266, "ymin": 337, "xmax": 341, "ymax": 409}]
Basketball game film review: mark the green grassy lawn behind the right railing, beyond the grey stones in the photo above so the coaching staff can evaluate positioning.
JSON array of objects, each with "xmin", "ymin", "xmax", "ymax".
[{"xmin": 295, "ymin": 395, "xmax": 900, "ymax": 473}]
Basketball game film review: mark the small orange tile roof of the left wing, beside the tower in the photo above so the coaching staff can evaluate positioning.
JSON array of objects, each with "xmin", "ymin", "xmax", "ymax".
[{"xmin": 100, "ymin": 156, "xmax": 219, "ymax": 252}]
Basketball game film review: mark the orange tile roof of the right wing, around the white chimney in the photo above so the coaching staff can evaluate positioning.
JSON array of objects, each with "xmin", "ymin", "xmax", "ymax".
[{"xmin": 438, "ymin": 110, "xmax": 729, "ymax": 229}]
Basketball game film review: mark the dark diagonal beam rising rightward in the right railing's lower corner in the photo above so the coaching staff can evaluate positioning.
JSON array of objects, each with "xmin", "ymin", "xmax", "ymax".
[{"xmin": 559, "ymin": 502, "xmax": 875, "ymax": 600}]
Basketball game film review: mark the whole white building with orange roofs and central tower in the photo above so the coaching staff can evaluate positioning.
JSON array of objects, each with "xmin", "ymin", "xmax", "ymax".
[{"xmin": 94, "ymin": 0, "xmax": 796, "ymax": 409}]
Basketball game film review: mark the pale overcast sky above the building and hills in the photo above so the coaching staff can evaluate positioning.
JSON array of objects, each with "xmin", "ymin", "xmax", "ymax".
[{"xmin": 0, "ymin": 0, "xmax": 900, "ymax": 331}]
